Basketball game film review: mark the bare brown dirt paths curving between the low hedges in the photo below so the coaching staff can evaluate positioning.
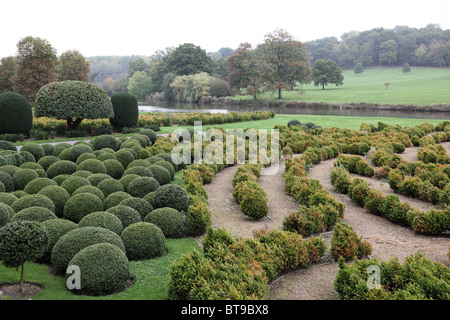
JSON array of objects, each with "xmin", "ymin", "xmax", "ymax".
[{"xmin": 205, "ymin": 142, "xmax": 450, "ymax": 300}]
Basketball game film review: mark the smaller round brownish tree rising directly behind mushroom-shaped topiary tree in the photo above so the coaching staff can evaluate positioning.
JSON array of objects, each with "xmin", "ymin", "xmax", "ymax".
[{"xmin": 56, "ymin": 50, "xmax": 91, "ymax": 82}]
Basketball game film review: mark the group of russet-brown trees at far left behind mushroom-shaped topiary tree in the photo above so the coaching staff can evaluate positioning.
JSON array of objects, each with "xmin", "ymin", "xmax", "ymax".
[{"xmin": 0, "ymin": 37, "xmax": 90, "ymax": 103}]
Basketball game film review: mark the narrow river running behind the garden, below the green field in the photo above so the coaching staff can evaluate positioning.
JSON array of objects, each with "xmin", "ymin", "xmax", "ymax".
[{"xmin": 139, "ymin": 101, "xmax": 450, "ymax": 120}]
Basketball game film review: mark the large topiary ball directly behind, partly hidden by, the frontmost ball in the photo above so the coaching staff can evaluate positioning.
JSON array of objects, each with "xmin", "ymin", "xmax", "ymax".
[{"xmin": 51, "ymin": 227, "xmax": 125, "ymax": 273}]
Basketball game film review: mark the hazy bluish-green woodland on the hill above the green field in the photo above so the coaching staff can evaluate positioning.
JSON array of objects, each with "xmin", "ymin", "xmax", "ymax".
[{"xmin": 305, "ymin": 24, "xmax": 450, "ymax": 69}]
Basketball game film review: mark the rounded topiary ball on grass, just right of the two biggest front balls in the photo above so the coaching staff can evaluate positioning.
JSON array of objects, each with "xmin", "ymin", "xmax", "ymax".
[{"xmin": 121, "ymin": 222, "xmax": 166, "ymax": 260}]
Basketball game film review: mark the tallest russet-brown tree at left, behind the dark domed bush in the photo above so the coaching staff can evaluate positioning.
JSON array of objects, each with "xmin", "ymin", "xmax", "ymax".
[{"xmin": 12, "ymin": 36, "xmax": 58, "ymax": 103}]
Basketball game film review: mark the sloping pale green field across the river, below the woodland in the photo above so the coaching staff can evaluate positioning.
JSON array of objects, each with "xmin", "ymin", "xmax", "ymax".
[{"xmin": 236, "ymin": 67, "xmax": 450, "ymax": 105}]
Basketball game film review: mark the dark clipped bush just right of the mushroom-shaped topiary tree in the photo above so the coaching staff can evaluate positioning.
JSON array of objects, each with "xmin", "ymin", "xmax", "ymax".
[{"xmin": 109, "ymin": 92, "xmax": 139, "ymax": 128}]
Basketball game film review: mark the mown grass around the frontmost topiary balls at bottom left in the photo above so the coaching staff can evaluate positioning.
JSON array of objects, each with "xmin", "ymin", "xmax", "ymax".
[{"xmin": 0, "ymin": 238, "xmax": 199, "ymax": 300}]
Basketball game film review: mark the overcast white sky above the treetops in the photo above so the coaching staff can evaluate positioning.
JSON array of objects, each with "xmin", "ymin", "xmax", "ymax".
[{"xmin": 0, "ymin": 0, "xmax": 450, "ymax": 57}]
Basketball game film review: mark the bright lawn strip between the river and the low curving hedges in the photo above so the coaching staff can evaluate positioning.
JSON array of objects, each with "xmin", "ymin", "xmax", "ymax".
[{"xmin": 161, "ymin": 114, "xmax": 443, "ymax": 133}]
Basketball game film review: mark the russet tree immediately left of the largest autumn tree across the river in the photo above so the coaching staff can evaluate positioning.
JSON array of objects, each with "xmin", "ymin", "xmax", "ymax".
[{"xmin": 227, "ymin": 43, "xmax": 264, "ymax": 99}]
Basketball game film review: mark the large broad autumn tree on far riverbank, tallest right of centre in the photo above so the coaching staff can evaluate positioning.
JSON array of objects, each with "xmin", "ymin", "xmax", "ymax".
[{"xmin": 258, "ymin": 29, "xmax": 311, "ymax": 99}]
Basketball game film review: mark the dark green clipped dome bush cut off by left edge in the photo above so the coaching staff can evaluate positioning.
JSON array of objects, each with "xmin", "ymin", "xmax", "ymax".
[{"xmin": 0, "ymin": 92, "xmax": 33, "ymax": 135}]
